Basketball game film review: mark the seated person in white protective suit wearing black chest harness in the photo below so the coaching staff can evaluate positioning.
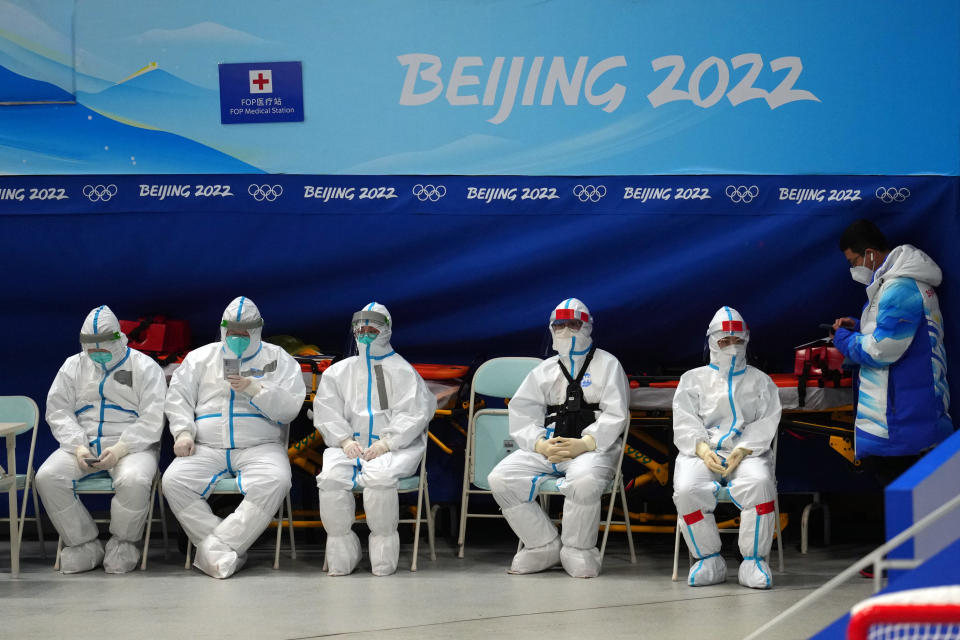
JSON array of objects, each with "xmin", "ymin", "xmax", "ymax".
[{"xmin": 488, "ymin": 298, "xmax": 630, "ymax": 578}]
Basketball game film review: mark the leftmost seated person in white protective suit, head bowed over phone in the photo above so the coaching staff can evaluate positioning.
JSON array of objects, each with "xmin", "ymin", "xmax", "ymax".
[{"xmin": 36, "ymin": 305, "xmax": 166, "ymax": 573}]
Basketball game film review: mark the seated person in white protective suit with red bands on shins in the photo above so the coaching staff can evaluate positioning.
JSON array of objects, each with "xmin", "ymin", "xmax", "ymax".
[{"xmin": 673, "ymin": 307, "xmax": 780, "ymax": 589}]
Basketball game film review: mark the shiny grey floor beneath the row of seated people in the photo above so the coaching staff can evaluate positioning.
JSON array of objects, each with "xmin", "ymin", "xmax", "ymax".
[{"xmin": 0, "ymin": 534, "xmax": 871, "ymax": 640}]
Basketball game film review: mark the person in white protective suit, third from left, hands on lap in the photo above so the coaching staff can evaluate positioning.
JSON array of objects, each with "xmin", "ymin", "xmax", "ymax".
[{"xmin": 313, "ymin": 302, "xmax": 437, "ymax": 576}]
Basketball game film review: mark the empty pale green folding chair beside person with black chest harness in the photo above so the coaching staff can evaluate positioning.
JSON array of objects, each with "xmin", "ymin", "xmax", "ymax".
[{"xmin": 457, "ymin": 357, "xmax": 542, "ymax": 558}]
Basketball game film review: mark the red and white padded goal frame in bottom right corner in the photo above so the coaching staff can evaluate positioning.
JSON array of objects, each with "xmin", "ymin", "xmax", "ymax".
[{"xmin": 847, "ymin": 585, "xmax": 960, "ymax": 640}]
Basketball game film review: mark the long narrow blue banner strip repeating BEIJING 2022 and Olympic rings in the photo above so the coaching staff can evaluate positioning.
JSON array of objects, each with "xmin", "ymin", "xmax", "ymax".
[{"xmin": 0, "ymin": 174, "xmax": 952, "ymax": 216}]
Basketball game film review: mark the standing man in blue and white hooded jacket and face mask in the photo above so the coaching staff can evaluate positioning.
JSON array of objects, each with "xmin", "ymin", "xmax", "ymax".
[{"xmin": 833, "ymin": 220, "xmax": 953, "ymax": 458}]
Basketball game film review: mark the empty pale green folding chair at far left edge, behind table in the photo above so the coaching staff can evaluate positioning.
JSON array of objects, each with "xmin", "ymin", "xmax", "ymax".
[{"xmin": 0, "ymin": 396, "xmax": 47, "ymax": 576}]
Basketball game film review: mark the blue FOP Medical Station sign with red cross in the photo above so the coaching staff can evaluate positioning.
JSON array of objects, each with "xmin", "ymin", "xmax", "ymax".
[{"xmin": 219, "ymin": 62, "xmax": 303, "ymax": 124}]
